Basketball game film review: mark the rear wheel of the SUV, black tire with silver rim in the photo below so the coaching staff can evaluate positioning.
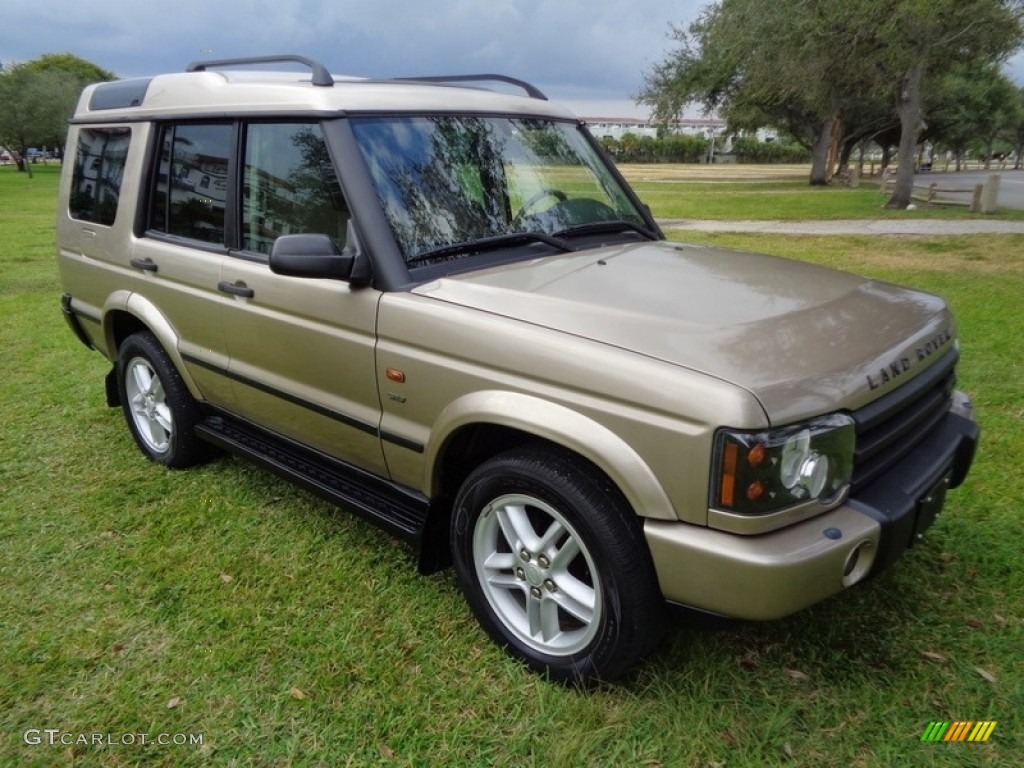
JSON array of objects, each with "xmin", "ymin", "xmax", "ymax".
[{"xmin": 118, "ymin": 331, "xmax": 212, "ymax": 469}]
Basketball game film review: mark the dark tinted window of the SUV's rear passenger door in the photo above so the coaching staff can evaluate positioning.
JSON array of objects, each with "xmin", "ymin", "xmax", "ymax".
[{"xmin": 150, "ymin": 123, "xmax": 232, "ymax": 244}]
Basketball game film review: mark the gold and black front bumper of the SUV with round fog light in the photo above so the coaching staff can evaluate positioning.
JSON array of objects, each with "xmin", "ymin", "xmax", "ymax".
[{"xmin": 644, "ymin": 393, "xmax": 979, "ymax": 620}]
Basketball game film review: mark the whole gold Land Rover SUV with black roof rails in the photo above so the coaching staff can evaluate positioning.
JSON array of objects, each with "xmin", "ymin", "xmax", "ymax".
[{"xmin": 57, "ymin": 56, "xmax": 978, "ymax": 682}]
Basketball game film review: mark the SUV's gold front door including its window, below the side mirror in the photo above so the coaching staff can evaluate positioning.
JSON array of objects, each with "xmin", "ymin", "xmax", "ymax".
[{"xmin": 220, "ymin": 121, "xmax": 386, "ymax": 474}]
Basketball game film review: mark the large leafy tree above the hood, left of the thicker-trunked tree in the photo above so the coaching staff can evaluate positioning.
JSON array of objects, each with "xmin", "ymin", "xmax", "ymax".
[{"xmin": 638, "ymin": 0, "xmax": 873, "ymax": 184}]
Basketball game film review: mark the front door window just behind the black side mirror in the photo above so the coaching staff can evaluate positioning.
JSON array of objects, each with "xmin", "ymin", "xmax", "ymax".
[{"xmin": 242, "ymin": 123, "xmax": 349, "ymax": 253}]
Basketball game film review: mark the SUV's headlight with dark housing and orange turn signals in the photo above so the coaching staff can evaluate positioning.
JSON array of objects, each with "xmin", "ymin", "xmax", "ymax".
[{"xmin": 710, "ymin": 414, "xmax": 855, "ymax": 515}]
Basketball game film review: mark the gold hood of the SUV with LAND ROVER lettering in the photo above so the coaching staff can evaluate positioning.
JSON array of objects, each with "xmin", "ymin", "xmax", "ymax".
[{"xmin": 416, "ymin": 243, "xmax": 954, "ymax": 424}]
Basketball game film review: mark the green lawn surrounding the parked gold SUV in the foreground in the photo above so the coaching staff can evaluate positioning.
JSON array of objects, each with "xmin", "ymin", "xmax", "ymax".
[{"xmin": 0, "ymin": 169, "xmax": 1024, "ymax": 768}]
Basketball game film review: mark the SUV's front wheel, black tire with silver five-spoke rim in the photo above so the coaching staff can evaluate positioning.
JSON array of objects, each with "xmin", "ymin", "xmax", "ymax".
[{"xmin": 452, "ymin": 445, "xmax": 665, "ymax": 685}]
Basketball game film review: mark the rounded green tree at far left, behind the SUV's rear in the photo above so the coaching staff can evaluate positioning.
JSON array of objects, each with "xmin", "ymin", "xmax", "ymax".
[{"xmin": 0, "ymin": 53, "xmax": 116, "ymax": 174}]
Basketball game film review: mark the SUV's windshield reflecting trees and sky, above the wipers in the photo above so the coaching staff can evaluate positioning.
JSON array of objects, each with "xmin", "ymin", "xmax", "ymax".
[{"xmin": 351, "ymin": 116, "xmax": 650, "ymax": 264}]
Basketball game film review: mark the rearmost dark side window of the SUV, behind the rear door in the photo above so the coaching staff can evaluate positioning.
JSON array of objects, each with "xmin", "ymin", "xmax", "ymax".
[{"xmin": 68, "ymin": 128, "xmax": 131, "ymax": 226}]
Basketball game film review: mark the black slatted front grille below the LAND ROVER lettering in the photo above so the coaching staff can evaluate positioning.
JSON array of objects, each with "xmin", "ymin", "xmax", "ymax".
[{"xmin": 853, "ymin": 349, "xmax": 958, "ymax": 493}]
